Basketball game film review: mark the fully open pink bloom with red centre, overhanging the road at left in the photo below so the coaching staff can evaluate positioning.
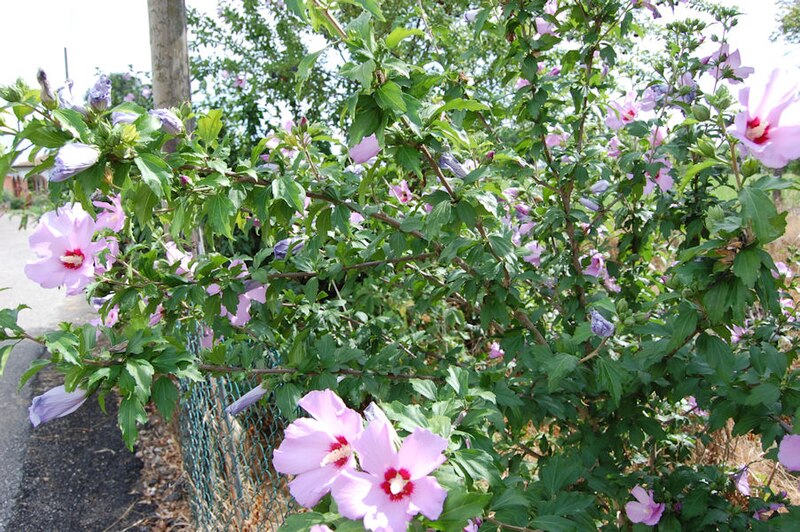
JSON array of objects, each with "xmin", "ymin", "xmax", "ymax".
[{"xmin": 25, "ymin": 203, "xmax": 104, "ymax": 295}]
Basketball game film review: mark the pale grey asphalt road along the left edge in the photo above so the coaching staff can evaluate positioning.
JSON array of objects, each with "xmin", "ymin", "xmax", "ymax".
[{"xmin": 0, "ymin": 215, "xmax": 88, "ymax": 530}]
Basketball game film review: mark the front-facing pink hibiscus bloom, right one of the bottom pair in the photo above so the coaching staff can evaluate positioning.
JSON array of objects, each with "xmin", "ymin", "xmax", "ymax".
[{"xmin": 332, "ymin": 418, "xmax": 447, "ymax": 531}]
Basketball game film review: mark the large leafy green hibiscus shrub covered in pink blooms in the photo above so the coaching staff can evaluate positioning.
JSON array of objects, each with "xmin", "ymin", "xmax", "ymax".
[{"xmin": 0, "ymin": 0, "xmax": 800, "ymax": 531}]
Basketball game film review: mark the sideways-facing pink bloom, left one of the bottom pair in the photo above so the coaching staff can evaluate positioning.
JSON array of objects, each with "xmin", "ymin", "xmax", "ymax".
[{"xmin": 272, "ymin": 390, "xmax": 364, "ymax": 508}]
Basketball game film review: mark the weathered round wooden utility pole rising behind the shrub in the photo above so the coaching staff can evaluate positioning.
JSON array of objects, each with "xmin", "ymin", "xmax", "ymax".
[{"xmin": 147, "ymin": 0, "xmax": 191, "ymax": 108}]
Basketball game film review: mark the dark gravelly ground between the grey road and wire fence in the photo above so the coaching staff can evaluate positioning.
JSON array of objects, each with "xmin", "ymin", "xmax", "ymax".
[{"xmin": 7, "ymin": 370, "xmax": 153, "ymax": 532}]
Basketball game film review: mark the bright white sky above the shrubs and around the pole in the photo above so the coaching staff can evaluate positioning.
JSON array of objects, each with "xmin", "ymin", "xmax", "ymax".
[{"xmin": 0, "ymin": 0, "xmax": 800, "ymax": 103}]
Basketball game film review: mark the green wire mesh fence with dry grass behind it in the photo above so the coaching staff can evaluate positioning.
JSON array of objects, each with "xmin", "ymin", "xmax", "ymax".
[{"xmin": 180, "ymin": 370, "xmax": 292, "ymax": 532}]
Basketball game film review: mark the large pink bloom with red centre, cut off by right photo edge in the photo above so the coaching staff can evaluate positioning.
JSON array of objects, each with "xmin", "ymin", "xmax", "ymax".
[{"xmin": 730, "ymin": 69, "xmax": 800, "ymax": 168}]
